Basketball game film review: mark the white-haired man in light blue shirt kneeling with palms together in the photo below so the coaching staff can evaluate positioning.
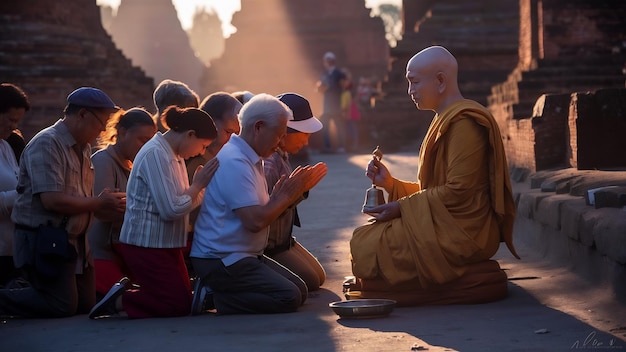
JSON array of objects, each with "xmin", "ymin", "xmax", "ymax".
[{"xmin": 190, "ymin": 94, "xmax": 327, "ymax": 314}]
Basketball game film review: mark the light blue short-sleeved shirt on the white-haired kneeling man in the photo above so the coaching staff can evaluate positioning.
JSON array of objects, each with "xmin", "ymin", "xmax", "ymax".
[{"xmin": 190, "ymin": 135, "xmax": 269, "ymax": 266}]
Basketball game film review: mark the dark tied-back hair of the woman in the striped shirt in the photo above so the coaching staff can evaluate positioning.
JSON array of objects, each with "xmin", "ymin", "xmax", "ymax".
[{"xmin": 162, "ymin": 105, "xmax": 217, "ymax": 139}]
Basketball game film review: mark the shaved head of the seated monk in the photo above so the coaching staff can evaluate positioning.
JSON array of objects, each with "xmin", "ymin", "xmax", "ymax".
[{"xmin": 406, "ymin": 46, "xmax": 463, "ymax": 112}]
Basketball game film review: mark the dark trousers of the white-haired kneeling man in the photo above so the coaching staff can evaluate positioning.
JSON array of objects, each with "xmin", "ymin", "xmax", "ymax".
[{"xmin": 191, "ymin": 256, "xmax": 308, "ymax": 314}]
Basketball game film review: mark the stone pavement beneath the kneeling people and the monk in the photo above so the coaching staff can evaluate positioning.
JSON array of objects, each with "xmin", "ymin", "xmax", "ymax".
[{"xmin": 0, "ymin": 153, "xmax": 626, "ymax": 351}]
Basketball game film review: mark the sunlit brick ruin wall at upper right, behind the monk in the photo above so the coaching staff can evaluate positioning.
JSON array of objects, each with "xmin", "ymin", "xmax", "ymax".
[{"xmin": 488, "ymin": 0, "xmax": 626, "ymax": 172}]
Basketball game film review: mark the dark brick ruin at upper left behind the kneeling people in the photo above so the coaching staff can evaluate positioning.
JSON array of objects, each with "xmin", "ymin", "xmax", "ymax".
[{"xmin": 0, "ymin": 0, "xmax": 154, "ymax": 139}]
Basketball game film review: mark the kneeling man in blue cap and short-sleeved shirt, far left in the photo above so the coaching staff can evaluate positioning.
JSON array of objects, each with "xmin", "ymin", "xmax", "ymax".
[{"xmin": 0, "ymin": 87, "xmax": 126, "ymax": 317}]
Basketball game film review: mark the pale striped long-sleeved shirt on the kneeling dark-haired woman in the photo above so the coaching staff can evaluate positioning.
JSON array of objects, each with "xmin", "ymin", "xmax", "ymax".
[{"xmin": 120, "ymin": 132, "xmax": 204, "ymax": 248}]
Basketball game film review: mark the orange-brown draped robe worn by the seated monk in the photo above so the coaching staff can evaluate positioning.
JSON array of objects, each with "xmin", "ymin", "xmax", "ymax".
[{"xmin": 350, "ymin": 100, "xmax": 519, "ymax": 287}]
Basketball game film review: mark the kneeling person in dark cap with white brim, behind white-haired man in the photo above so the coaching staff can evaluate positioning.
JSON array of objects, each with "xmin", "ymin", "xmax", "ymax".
[{"xmin": 263, "ymin": 93, "xmax": 326, "ymax": 291}]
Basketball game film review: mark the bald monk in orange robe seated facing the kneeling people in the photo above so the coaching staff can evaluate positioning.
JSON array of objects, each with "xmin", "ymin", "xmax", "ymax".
[{"xmin": 350, "ymin": 46, "xmax": 519, "ymax": 306}]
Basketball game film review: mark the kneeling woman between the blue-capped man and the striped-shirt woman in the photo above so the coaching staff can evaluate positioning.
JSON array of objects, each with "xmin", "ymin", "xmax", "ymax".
[{"xmin": 87, "ymin": 108, "xmax": 156, "ymax": 297}]
